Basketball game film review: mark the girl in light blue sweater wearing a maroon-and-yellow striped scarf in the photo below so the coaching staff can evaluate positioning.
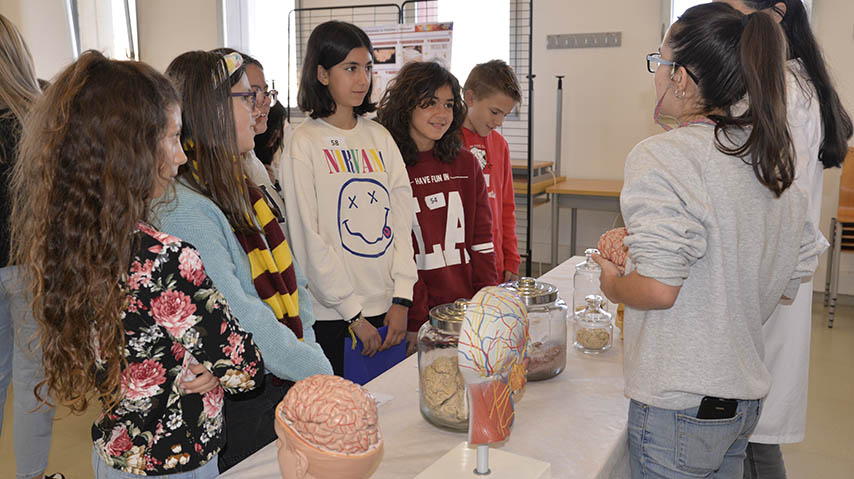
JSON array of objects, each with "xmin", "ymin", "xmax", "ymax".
[{"xmin": 158, "ymin": 51, "xmax": 332, "ymax": 472}]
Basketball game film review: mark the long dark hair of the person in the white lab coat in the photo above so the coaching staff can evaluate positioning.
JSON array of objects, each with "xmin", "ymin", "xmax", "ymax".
[{"xmin": 743, "ymin": 0, "xmax": 854, "ymax": 168}]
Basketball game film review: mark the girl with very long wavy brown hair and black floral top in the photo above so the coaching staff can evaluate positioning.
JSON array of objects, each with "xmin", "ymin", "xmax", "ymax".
[{"xmin": 12, "ymin": 51, "xmax": 263, "ymax": 478}]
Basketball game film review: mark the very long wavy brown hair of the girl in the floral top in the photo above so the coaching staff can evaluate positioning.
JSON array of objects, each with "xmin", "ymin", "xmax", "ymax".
[{"xmin": 12, "ymin": 51, "xmax": 180, "ymax": 413}]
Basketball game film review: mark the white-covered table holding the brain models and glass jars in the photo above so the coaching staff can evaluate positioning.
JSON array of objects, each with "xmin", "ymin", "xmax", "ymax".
[{"xmin": 220, "ymin": 256, "xmax": 630, "ymax": 479}]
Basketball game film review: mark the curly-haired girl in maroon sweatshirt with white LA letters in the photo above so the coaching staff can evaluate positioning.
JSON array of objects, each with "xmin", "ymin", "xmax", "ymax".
[{"xmin": 377, "ymin": 62, "xmax": 498, "ymax": 346}]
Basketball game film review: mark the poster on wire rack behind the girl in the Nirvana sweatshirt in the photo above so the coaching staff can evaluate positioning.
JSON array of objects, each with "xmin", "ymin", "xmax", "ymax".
[{"xmin": 363, "ymin": 22, "xmax": 454, "ymax": 102}]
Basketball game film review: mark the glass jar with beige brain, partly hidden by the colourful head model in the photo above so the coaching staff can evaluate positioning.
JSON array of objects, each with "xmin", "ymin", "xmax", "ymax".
[{"xmin": 418, "ymin": 299, "xmax": 469, "ymax": 431}]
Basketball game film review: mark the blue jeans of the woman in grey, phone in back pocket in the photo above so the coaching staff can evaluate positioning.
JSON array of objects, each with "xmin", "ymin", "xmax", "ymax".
[{"xmin": 628, "ymin": 399, "xmax": 762, "ymax": 479}]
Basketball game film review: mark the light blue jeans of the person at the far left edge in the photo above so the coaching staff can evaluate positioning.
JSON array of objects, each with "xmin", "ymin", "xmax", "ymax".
[{"xmin": 0, "ymin": 266, "xmax": 54, "ymax": 479}]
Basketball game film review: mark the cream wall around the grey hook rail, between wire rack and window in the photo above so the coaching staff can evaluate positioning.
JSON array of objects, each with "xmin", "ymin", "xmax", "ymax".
[{"xmin": 520, "ymin": 0, "xmax": 661, "ymax": 262}]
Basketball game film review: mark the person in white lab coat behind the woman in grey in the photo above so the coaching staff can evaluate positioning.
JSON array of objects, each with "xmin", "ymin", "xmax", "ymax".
[{"xmin": 725, "ymin": 0, "xmax": 852, "ymax": 479}]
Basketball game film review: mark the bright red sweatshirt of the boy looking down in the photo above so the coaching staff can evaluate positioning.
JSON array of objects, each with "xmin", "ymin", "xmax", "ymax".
[{"xmin": 463, "ymin": 127, "xmax": 522, "ymax": 281}]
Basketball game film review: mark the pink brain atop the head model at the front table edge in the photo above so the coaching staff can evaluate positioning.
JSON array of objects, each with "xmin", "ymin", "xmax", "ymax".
[{"xmin": 282, "ymin": 375, "xmax": 380, "ymax": 454}]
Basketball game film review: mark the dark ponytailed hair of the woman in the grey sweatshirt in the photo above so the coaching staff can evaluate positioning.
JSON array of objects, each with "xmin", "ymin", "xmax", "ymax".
[{"xmin": 668, "ymin": 2, "xmax": 795, "ymax": 196}]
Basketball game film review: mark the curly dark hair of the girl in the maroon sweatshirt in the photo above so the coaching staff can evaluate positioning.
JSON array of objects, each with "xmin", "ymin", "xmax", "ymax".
[{"xmin": 377, "ymin": 62, "xmax": 466, "ymax": 166}]
